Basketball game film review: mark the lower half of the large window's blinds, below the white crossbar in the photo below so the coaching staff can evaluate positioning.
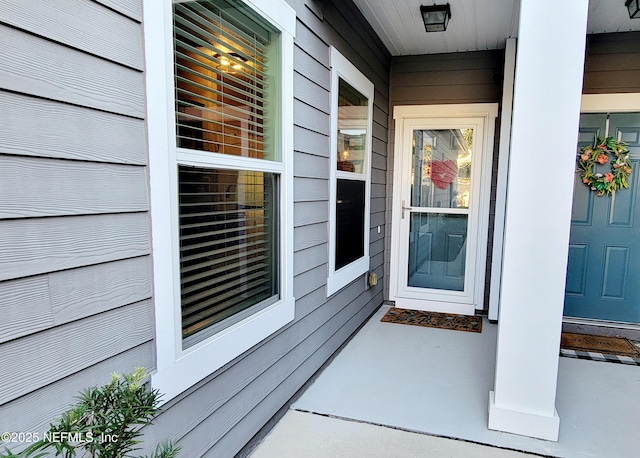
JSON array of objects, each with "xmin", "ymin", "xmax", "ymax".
[{"xmin": 178, "ymin": 166, "xmax": 278, "ymax": 338}]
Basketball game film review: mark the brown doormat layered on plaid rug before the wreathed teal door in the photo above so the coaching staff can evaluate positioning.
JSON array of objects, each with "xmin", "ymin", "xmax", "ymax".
[{"xmin": 560, "ymin": 332, "xmax": 640, "ymax": 366}]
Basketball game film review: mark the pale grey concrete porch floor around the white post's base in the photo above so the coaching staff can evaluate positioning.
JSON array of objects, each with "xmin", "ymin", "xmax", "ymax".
[{"xmin": 252, "ymin": 306, "xmax": 640, "ymax": 458}]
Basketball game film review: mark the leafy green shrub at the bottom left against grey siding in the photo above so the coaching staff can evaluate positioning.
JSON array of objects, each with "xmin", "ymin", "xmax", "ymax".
[{"xmin": 0, "ymin": 367, "xmax": 180, "ymax": 458}]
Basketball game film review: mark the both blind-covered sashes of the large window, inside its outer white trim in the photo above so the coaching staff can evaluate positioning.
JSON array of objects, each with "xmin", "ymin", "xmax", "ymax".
[{"xmin": 173, "ymin": 0, "xmax": 282, "ymax": 348}]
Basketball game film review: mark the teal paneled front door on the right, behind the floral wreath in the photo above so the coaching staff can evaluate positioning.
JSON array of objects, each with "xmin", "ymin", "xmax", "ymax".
[{"xmin": 564, "ymin": 113, "xmax": 640, "ymax": 323}]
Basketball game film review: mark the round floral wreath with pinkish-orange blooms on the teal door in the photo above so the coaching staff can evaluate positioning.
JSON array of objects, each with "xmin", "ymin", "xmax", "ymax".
[{"xmin": 578, "ymin": 137, "xmax": 633, "ymax": 196}]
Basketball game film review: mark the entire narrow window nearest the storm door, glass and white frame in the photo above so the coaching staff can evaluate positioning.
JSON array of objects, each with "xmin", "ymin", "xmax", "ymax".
[{"xmin": 327, "ymin": 48, "xmax": 374, "ymax": 295}]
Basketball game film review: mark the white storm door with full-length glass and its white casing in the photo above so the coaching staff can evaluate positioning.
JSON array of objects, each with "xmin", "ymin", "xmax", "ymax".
[{"xmin": 391, "ymin": 113, "xmax": 491, "ymax": 315}]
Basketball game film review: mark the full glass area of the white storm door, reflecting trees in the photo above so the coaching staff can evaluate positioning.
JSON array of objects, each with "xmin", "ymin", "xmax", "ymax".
[{"xmin": 407, "ymin": 128, "xmax": 473, "ymax": 291}]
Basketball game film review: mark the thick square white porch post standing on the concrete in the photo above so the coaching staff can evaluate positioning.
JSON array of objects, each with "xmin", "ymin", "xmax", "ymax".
[{"xmin": 489, "ymin": 0, "xmax": 588, "ymax": 440}]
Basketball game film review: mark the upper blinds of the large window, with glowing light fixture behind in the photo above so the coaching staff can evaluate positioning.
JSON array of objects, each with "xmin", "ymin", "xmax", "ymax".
[{"xmin": 173, "ymin": 0, "xmax": 277, "ymax": 159}]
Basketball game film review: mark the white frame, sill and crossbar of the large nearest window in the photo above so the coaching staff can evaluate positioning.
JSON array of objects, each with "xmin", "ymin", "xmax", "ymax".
[{"xmin": 143, "ymin": 0, "xmax": 296, "ymax": 402}]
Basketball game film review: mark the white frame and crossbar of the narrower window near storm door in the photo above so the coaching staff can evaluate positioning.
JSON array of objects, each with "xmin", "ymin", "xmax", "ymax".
[{"xmin": 327, "ymin": 46, "xmax": 375, "ymax": 297}]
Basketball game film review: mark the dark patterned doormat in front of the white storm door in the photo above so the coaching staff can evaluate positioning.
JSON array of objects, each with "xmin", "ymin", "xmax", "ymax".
[{"xmin": 380, "ymin": 307, "xmax": 482, "ymax": 332}]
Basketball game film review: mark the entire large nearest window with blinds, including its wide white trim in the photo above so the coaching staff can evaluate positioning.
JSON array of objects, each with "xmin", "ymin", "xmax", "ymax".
[{"xmin": 142, "ymin": 0, "xmax": 296, "ymax": 399}]
